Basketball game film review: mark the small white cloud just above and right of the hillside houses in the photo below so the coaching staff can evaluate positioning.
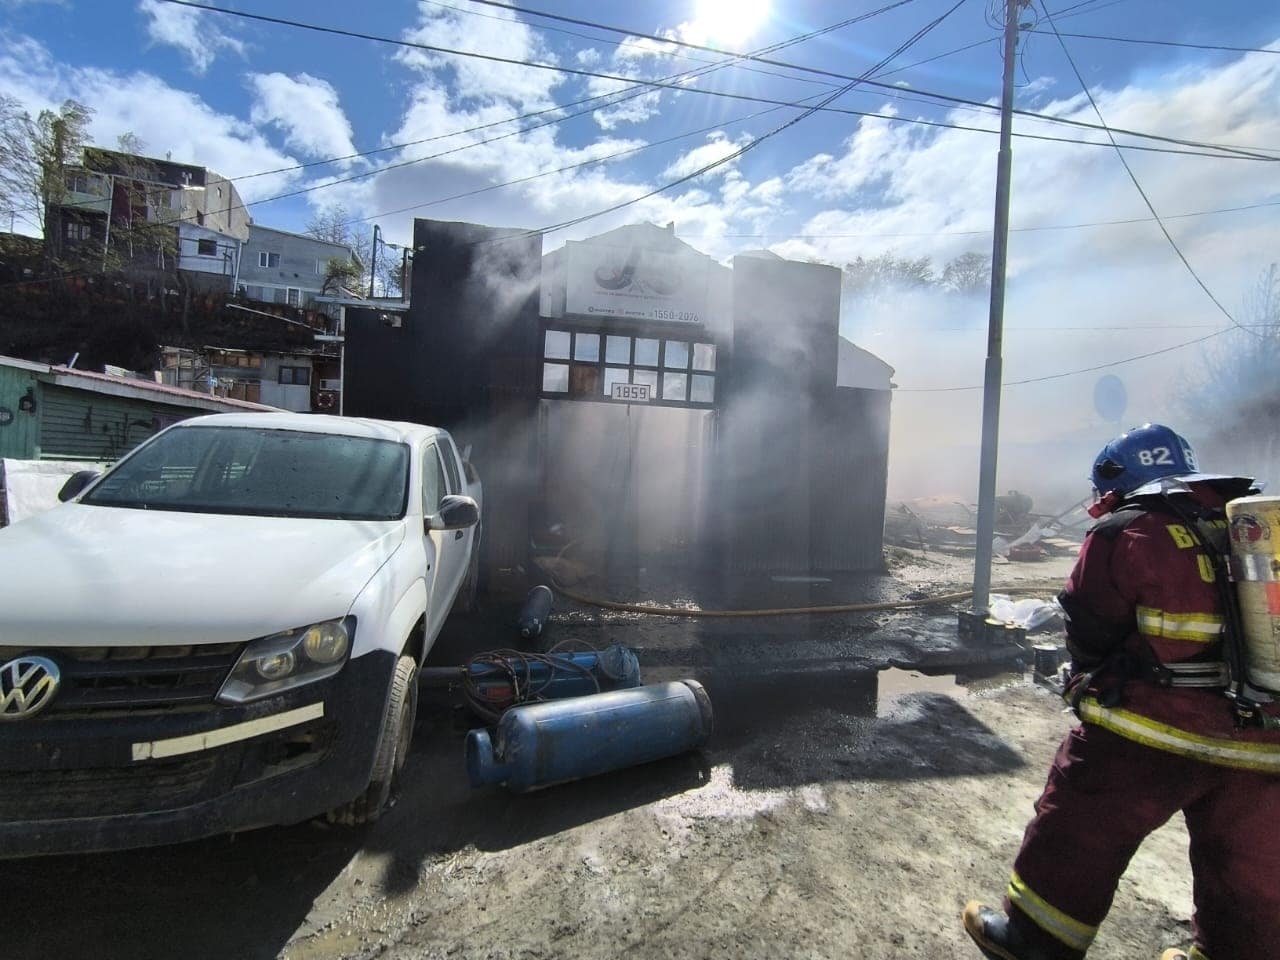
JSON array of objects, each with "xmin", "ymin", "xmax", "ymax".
[{"xmin": 248, "ymin": 73, "xmax": 356, "ymax": 166}]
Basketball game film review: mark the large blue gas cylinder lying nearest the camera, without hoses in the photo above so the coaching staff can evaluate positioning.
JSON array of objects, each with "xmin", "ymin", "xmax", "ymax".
[{"xmin": 466, "ymin": 680, "xmax": 712, "ymax": 794}]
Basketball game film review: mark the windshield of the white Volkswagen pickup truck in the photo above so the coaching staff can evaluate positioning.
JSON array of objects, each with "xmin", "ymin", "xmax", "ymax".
[{"xmin": 82, "ymin": 426, "xmax": 410, "ymax": 520}]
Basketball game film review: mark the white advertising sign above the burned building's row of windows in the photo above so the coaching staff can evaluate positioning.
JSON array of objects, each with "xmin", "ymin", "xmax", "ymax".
[{"xmin": 564, "ymin": 243, "xmax": 710, "ymax": 324}]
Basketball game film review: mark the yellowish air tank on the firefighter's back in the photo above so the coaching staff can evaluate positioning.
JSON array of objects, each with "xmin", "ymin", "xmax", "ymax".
[{"xmin": 1226, "ymin": 497, "xmax": 1280, "ymax": 694}]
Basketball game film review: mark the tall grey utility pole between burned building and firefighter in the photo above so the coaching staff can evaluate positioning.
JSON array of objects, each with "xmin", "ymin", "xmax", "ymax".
[{"xmin": 973, "ymin": 0, "xmax": 1030, "ymax": 618}]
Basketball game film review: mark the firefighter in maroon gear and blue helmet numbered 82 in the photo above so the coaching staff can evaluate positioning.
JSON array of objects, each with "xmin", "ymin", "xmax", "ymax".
[{"xmin": 963, "ymin": 424, "xmax": 1280, "ymax": 960}]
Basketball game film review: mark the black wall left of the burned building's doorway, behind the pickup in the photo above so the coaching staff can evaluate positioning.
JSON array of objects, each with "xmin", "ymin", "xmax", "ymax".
[{"xmin": 344, "ymin": 220, "xmax": 543, "ymax": 593}]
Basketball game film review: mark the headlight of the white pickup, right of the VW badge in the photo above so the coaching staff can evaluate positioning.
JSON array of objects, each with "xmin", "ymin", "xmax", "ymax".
[{"xmin": 218, "ymin": 617, "xmax": 356, "ymax": 703}]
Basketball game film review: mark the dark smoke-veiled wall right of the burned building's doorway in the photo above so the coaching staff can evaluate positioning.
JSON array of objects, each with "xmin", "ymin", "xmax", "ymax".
[{"xmin": 717, "ymin": 256, "xmax": 890, "ymax": 573}]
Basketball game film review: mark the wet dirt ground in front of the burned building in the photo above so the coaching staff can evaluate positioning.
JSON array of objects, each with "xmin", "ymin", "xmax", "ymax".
[{"xmin": 0, "ymin": 553, "xmax": 1190, "ymax": 960}]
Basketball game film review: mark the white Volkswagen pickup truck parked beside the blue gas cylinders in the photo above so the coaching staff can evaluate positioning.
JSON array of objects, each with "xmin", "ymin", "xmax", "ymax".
[{"xmin": 0, "ymin": 413, "xmax": 481, "ymax": 856}]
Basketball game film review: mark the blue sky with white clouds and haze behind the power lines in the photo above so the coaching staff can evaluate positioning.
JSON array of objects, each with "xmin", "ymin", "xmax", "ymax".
[{"xmin": 0, "ymin": 0, "xmax": 1280, "ymax": 490}]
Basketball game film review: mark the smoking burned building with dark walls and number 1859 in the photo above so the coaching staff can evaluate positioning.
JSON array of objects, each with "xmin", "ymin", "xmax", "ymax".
[{"xmin": 344, "ymin": 220, "xmax": 892, "ymax": 588}]
